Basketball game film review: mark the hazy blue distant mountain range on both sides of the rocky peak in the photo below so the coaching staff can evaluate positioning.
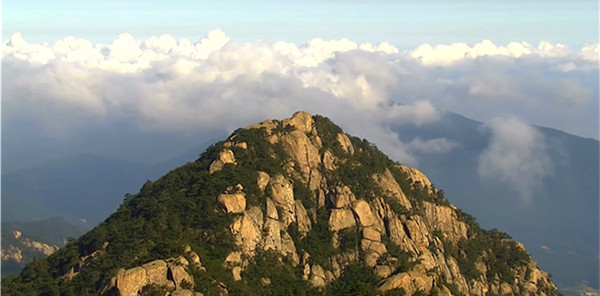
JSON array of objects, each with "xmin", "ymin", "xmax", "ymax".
[{"xmin": 2, "ymin": 112, "xmax": 599, "ymax": 289}]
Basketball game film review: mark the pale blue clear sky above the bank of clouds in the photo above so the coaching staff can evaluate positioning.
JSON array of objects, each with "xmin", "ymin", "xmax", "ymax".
[{"xmin": 2, "ymin": 0, "xmax": 598, "ymax": 49}]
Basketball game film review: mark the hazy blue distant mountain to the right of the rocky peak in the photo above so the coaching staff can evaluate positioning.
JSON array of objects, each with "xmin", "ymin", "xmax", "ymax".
[{"xmin": 393, "ymin": 112, "xmax": 600, "ymax": 289}]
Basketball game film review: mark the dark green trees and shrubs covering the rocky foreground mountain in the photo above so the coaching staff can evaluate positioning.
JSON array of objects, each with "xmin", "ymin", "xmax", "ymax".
[{"xmin": 2, "ymin": 115, "xmax": 554, "ymax": 295}]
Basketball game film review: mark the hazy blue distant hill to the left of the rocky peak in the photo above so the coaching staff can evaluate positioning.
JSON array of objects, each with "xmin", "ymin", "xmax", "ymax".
[{"xmin": 2, "ymin": 154, "xmax": 186, "ymax": 228}]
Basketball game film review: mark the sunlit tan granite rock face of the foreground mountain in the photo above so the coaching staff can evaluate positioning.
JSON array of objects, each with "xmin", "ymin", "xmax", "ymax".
[{"xmin": 8, "ymin": 112, "xmax": 555, "ymax": 296}]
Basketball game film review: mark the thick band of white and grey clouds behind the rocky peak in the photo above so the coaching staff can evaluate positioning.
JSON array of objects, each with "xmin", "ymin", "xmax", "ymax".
[{"xmin": 2, "ymin": 30, "xmax": 599, "ymax": 194}]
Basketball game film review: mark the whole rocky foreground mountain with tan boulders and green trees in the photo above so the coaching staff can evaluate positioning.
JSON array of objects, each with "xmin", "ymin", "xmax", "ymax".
[{"xmin": 2, "ymin": 112, "xmax": 558, "ymax": 296}]
